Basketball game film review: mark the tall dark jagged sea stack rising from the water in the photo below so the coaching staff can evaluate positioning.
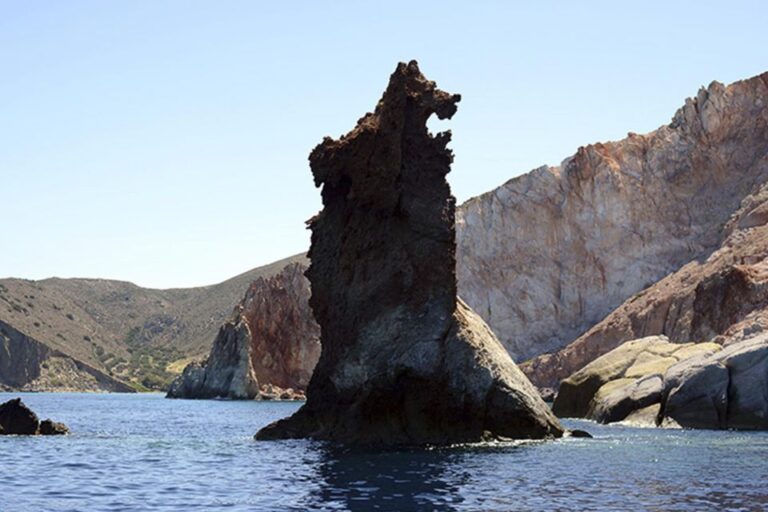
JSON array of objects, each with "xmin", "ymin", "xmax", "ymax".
[{"xmin": 256, "ymin": 61, "xmax": 563, "ymax": 444}]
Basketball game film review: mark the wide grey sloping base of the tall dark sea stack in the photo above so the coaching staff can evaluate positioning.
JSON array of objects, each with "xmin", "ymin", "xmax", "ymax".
[{"xmin": 256, "ymin": 302, "xmax": 563, "ymax": 445}]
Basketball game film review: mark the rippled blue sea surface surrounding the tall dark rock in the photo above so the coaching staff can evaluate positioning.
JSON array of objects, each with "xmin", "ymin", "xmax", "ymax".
[{"xmin": 0, "ymin": 393, "xmax": 768, "ymax": 512}]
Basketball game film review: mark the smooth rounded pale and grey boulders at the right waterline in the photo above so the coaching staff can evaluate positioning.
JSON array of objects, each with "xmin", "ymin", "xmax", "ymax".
[{"xmin": 553, "ymin": 333, "xmax": 768, "ymax": 430}]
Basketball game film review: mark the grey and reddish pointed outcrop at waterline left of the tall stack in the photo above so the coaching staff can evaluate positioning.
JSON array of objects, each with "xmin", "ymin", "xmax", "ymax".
[{"xmin": 168, "ymin": 262, "xmax": 320, "ymax": 400}]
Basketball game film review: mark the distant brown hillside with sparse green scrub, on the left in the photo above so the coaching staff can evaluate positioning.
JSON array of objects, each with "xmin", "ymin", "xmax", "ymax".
[{"xmin": 0, "ymin": 251, "xmax": 305, "ymax": 389}]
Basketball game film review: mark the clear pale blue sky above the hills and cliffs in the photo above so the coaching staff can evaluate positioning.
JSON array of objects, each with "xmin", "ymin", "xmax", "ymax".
[{"xmin": 0, "ymin": 0, "xmax": 768, "ymax": 288}]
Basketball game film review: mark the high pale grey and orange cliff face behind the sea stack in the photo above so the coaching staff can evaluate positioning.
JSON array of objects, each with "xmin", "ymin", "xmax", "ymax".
[{"xmin": 457, "ymin": 73, "xmax": 768, "ymax": 360}]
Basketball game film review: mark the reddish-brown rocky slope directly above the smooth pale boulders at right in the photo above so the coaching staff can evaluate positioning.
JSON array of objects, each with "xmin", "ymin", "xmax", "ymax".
[{"xmin": 523, "ymin": 177, "xmax": 768, "ymax": 385}]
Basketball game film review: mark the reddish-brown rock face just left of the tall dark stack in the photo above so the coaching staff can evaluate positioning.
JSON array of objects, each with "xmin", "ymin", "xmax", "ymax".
[{"xmin": 240, "ymin": 263, "xmax": 320, "ymax": 390}]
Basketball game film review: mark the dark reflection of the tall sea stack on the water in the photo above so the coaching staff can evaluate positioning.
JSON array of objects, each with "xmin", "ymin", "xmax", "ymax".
[{"xmin": 307, "ymin": 445, "xmax": 470, "ymax": 512}]
